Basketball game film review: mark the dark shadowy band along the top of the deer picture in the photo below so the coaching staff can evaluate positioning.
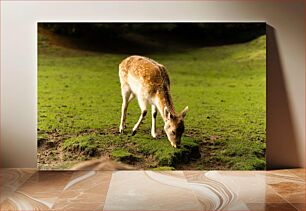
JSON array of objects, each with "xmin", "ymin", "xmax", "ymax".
[{"xmin": 39, "ymin": 23, "xmax": 266, "ymax": 53}]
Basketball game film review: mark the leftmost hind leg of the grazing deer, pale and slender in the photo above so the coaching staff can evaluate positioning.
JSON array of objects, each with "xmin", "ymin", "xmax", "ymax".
[{"xmin": 119, "ymin": 84, "xmax": 134, "ymax": 133}]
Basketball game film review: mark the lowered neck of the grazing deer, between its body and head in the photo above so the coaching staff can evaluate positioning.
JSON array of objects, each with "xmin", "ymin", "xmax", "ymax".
[{"xmin": 155, "ymin": 90, "xmax": 176, "ymax": 122}]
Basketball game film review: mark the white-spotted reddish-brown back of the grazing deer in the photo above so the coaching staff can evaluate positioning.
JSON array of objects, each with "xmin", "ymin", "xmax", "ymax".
[{"xmin": 119, "ymin": 56, "xmax": 170, "ymax": 92}]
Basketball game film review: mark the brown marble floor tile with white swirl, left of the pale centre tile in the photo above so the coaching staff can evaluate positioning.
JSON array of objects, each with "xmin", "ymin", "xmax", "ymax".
[{"xmin": 0, "ymin": 171, "xmax": 112, "ymax": 210}]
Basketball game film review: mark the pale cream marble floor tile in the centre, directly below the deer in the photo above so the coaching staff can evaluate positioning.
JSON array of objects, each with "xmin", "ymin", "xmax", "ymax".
[{"xmin": 104, "ymin": 171, "xmax": 201, "ymax": 210}]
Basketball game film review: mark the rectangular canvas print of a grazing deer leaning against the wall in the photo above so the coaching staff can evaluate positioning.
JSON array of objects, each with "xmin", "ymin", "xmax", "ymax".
[{"xmin": 37, "ymin": 22, "xmax": 266, "ymax": 170}]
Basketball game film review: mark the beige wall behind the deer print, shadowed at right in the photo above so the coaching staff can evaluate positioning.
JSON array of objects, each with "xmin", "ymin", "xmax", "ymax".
[{"xmin": 0, "ymin": 0, "xmax": 305, "ymax": 168}]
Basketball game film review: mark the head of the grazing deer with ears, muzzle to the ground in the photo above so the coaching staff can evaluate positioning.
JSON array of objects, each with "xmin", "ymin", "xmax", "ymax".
[{"xmin": 164, "ymin": 106, "xmax": 188, "ymax": 148}]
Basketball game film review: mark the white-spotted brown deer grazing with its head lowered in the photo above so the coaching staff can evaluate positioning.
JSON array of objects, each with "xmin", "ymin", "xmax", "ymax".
[{"xmin": 119, "ymin": 55, "xmax": 188, "ymax": 148}]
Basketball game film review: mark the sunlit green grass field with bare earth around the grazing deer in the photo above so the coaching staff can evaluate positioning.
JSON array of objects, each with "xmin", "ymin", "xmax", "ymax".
[{"xmin": 37, "ymin": 29, "xmax": 266, "ymax": 170}]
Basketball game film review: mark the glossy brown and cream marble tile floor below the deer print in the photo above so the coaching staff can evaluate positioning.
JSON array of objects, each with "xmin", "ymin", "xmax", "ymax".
[{"xmin": 0, "ymin": 169, "xmax": 306, "ymax": 211}]
